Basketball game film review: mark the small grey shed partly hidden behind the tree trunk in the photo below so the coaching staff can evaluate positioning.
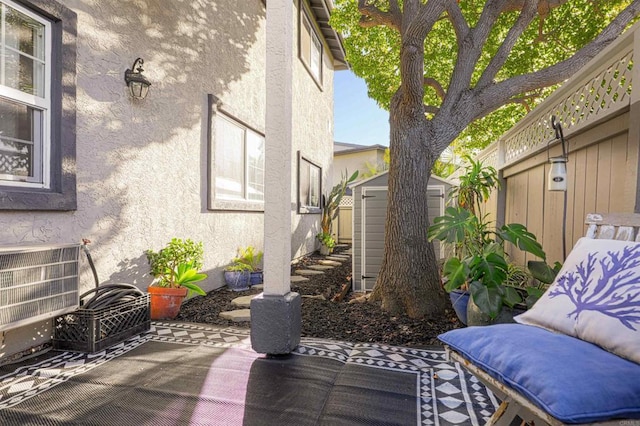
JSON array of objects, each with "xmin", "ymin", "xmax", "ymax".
[{"xmin": 352, "ymin": 172, "xmax": 453, "ymax": 291}]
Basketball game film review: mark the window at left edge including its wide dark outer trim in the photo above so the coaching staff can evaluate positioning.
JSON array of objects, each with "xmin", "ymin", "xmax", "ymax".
[{"xmin": 0, "ymin": 0, "xmax": 76, "ymax": 210}]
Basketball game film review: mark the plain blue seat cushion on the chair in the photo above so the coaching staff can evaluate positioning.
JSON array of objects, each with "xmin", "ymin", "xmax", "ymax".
[{"xmin": 438, "ymin": 324, "xmax": 640, "ymax": 423}]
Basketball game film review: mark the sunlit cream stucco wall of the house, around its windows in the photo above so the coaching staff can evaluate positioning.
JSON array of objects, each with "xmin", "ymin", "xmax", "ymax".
[{"xmin": 0, "ymin": 0, "xmax": 333, "ymax": 358}]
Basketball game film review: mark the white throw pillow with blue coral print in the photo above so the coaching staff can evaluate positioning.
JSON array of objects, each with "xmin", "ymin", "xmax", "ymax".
[{"xmin": 515, "ymin": 238, "xmax": 640, "ymax": 364}]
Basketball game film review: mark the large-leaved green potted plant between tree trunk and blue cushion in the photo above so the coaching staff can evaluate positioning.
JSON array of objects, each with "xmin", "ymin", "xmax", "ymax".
[{"xmin": 428, "ymin": 207, "xmax": 546, "ymax": 325}]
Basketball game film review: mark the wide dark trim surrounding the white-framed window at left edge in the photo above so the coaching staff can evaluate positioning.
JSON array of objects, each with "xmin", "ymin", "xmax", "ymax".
[{"xmin": 0, "ymin": 0, "xmax": 77, "ymax": 211}]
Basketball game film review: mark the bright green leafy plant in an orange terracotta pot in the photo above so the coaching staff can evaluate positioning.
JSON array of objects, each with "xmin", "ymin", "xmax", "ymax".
[{"xmin": 146, "ymin": 238, "xmax": 207, "ymax": 320}]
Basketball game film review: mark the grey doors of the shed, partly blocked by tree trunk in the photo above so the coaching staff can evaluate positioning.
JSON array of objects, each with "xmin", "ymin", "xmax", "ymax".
[{"xmin": 359, "ymin": 186, "xmax": 444, "ymax": 291}]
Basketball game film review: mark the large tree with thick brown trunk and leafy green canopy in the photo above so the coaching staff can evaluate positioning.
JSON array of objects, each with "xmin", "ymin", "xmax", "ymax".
[{"xmin": 331, "ymin": 0, "xmax": 640, "ymax": 318}]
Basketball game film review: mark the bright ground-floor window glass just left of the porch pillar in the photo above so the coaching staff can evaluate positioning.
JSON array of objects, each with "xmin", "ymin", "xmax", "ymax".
[{"xmin": 210, "ymin": 103, "xmax": 265, "ymax": 210}]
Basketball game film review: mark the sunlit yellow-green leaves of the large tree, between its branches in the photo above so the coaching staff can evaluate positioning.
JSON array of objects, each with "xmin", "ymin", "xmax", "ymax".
[{"xmin": 331, "ymin": 0, "xmax": 631, "ymax": 152}]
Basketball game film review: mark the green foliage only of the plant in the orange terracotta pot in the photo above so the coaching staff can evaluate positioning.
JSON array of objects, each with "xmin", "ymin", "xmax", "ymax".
[{"xmin": 145, "ymin": 238, "xmax": 207, "ymax": 294}]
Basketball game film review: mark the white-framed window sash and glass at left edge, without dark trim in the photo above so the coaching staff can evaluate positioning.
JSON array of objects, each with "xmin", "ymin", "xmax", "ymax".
[{"xmin": 0, "ymin": 1, "xmax": 51, "ymax": 188}]
